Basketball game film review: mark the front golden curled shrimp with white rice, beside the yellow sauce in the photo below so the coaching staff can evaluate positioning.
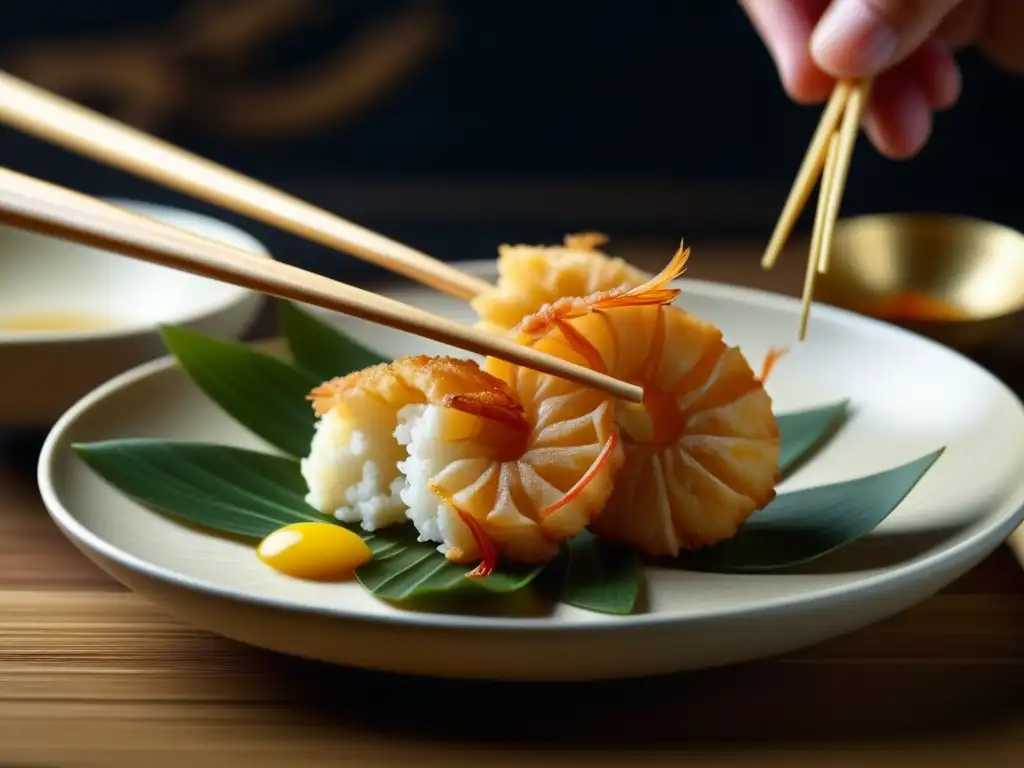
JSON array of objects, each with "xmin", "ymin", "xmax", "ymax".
[{"xmin": 302, "ymin": 355, "xmax": 623, "ymax": 575}]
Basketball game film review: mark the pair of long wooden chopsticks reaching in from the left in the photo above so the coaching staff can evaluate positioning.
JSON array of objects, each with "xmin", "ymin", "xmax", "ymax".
[{"xmin": 0, "ymin": 72, "xmax": 643, "ymax": 402}]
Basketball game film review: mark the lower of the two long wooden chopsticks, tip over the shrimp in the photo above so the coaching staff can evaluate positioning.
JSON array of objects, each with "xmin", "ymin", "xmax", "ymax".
[{"xmin": 0, "ymin": 169, "xmax": 643, "ymax": 402}]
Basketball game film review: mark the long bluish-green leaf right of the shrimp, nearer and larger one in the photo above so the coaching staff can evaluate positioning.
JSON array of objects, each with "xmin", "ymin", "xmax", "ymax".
[{"xmin": 680, "ymin": 449, "xmax": 945, "ymax": 572}]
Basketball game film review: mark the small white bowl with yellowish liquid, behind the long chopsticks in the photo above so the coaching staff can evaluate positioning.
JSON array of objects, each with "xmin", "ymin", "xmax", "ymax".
[{"xmin": 0, "ymin": 200, "xmax": 270, "ymax": 429}]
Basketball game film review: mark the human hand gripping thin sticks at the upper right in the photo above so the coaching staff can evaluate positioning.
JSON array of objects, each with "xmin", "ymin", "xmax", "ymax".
[{"xmin": 740, "ymin": 0, "xmax": 1024, "ymax": 159}]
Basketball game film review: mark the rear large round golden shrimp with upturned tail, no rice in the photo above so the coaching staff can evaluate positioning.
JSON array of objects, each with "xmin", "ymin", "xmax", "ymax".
[{"xmin": 487, "ymin": 247, "xmax": 780, "ymax": 556}]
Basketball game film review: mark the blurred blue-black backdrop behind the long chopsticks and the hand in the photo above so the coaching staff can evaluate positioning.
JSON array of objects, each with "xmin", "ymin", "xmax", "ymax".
[{"xmin": 0, "ymin": 0, "xmax": 1024, "ymax": 279}]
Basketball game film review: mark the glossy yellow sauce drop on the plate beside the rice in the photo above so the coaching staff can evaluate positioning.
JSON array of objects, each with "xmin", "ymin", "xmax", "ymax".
[{"xmin": 256, "ymin": 522, "xmax": 373, "ymax": 582}]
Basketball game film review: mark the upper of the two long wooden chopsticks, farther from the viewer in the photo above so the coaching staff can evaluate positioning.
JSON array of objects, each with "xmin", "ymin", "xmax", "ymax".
[{"xmin": 0, "ymin": 72, "xmax": 490, "ymax": 299}]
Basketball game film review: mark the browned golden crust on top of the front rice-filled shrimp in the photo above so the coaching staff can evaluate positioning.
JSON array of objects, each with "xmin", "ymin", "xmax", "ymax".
[{"xmin": 307, "ymin": 354, "xmax": 528, "ymax": 434}]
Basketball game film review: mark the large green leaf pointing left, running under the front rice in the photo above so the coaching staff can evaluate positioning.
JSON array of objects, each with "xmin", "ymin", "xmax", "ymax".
[{"xmin": 74, "ymin": 438, "xmax": 541, "ymax": 600}]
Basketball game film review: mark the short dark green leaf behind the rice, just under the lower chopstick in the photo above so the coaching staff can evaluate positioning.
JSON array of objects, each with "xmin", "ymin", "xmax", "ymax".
[{"xmin": 276, "ymin": 299, "xmax": 388, "ymax": 381}]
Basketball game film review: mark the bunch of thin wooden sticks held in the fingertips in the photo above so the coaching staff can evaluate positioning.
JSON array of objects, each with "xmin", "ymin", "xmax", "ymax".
[{"xmin": 761, "ymin": 79, "xmax": 871, "ymax": 341}]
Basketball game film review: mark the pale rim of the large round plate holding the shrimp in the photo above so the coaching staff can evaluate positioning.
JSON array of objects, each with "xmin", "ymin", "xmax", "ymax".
[{"xmin": 36, "ymin": 276, "xmax": 1024, "ymax": 635}]
